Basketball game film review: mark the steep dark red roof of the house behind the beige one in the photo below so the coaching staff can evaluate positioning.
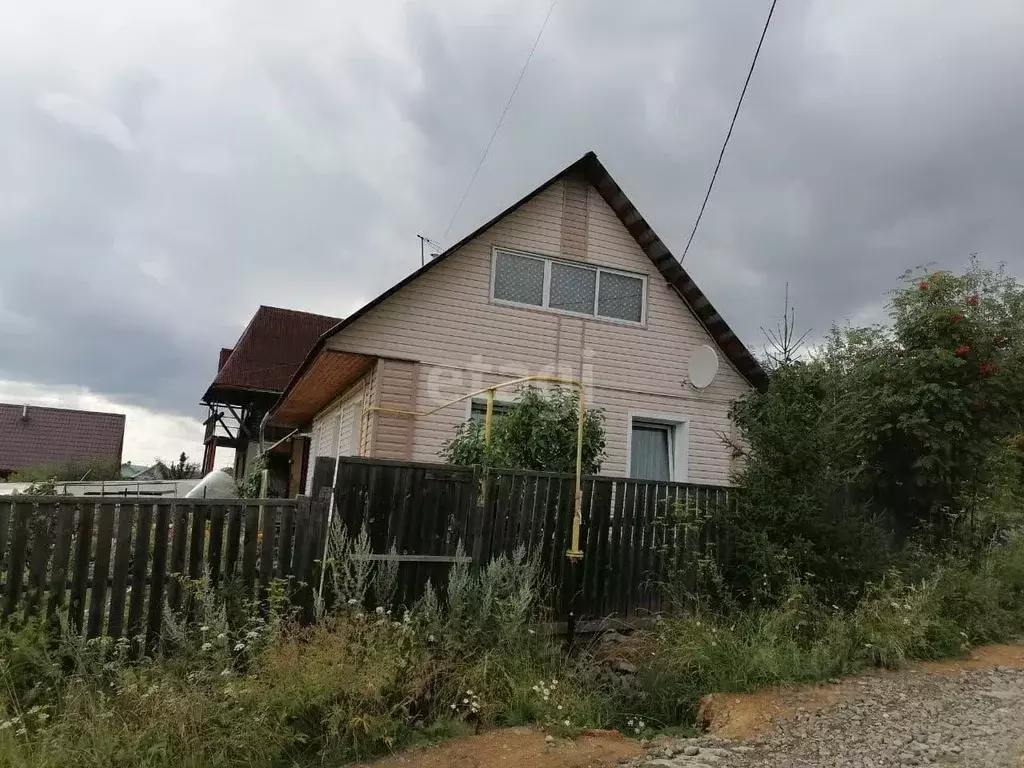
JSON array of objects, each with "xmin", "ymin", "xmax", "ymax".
[{"xmin": 208, "ymin": 306, "xmax": 340, "ymax": 394}]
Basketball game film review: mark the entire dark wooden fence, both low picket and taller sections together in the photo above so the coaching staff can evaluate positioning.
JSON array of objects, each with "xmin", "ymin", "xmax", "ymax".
[{"xmin": 0, "ymin": 458, "xmax": 733, "ymax": 648}]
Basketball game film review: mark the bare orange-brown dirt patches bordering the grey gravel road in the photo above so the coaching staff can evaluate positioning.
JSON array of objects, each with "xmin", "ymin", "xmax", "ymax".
[{"xmin": 358, "ymin": 645, "xmax": 1024, "ymax": 768}]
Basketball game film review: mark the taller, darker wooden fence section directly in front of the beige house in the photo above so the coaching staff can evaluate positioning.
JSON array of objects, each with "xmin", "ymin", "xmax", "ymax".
[{"xmin": 314, "ymin": 457, "xmax": 734, "ymax": 620}]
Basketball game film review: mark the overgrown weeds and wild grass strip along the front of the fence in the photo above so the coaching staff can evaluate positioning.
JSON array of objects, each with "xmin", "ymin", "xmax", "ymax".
[{"xmin": 0, "ymin": 537, "xmax": 1024, "ymax": 768}]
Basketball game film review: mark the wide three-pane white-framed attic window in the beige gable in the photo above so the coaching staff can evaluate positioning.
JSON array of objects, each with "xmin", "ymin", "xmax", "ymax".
[{"xmin": 492, "ymin": 249, "xmax": 647, "ymax": 325}]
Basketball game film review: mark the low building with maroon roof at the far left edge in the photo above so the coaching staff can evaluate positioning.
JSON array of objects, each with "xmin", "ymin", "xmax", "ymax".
[{"xmin": 0, "ymin": 403, "xmax": 125, "ymax": 479}]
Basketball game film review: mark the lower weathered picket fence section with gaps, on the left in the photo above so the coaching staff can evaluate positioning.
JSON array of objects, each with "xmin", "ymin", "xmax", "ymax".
[{"xmin": 0, "ymin": 497, "xmax": 327, "ymax": 647}]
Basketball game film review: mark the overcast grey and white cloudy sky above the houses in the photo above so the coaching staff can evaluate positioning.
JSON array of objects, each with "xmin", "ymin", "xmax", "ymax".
[{"xmin": 0, "ymin": 0, "xmax": 1024, "ymax": 462}]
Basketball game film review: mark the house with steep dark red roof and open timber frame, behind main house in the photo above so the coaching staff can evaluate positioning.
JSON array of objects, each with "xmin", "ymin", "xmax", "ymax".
[{"xmin": 202, "ymin": 306, "xmax": 338, "ymax": 496}]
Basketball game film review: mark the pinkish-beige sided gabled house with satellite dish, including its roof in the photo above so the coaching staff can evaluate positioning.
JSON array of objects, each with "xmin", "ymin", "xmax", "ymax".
[{"xmin": 269, "ymin": 153, "xmax": 765, "ymax": 488}]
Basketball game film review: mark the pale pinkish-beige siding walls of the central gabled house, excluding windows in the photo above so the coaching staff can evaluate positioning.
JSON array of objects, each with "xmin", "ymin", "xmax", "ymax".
[{"xmin": 329, "ymin": 180, "xmax": 748, "ymax": 483}]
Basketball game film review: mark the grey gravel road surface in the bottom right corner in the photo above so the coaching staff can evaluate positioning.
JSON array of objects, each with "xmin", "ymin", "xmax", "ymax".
[{"xmin": 624, "ymin": 667, "xmax": 1024, "ymax": 768}]
